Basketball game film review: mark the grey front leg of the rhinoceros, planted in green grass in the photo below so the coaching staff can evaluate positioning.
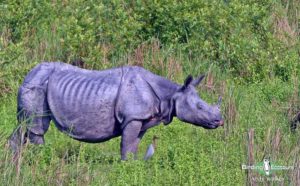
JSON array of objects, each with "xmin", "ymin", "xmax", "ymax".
[{"xmin": 121, "ymin": 121, "xmax": 146, "ymax": 160}]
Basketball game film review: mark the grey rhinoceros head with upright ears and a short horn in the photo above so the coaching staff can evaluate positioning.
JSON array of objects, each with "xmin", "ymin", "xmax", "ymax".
[{"xmin": 171, "ymin": 75, "xmax": 224, "ymax": 129}]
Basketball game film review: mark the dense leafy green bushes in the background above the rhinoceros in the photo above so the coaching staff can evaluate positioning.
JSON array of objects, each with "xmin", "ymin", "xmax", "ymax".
[{"xmin": 0, "ymin": 0, "xmax": 299, "ymax": 82}]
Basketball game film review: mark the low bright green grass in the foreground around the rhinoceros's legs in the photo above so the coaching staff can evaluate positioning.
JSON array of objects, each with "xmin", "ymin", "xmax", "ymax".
[{"xmin": 0, "ymin": 60, "xmax": 300, "ymax": 185}]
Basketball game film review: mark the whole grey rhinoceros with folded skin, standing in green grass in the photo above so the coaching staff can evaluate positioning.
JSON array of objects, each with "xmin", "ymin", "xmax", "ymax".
[{"xmin": 9, "ymin": 62, "xmax": 223, "ymax": 160}]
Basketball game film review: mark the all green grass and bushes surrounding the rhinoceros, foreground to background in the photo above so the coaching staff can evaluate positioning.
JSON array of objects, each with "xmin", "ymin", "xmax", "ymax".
[{"xmin": 0, "ymin": 0, "xmax": 300, "ymax": 185}]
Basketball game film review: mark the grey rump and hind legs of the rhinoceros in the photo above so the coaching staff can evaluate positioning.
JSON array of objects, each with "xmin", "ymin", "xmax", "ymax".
[{"xmin": 9, "ymin": 63, "xmax": 56, "ymax": 152}]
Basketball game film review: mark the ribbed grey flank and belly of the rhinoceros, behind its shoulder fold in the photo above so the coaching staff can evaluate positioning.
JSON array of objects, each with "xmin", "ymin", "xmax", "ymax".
[{"xmin": 47, "ymin": 71, "xmax": 121, "ymax": 142}]
